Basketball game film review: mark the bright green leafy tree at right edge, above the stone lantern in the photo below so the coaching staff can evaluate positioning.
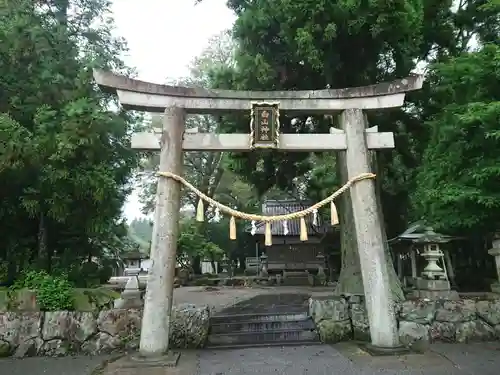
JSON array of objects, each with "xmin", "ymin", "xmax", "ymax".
[{"xmin": 415, "ymin": 44, "xmax": 500, "ymax": 233}]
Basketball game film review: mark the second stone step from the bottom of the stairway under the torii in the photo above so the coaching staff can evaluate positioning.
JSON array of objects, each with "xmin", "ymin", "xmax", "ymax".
[{"xmin": 210, "ymin": 319, "xmax": 315, "ymax": 334}]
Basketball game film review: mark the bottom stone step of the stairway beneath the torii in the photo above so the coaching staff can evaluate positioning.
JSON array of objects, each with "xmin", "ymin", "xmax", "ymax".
[{"xmin": 208, "ymin": 329, "xmax": 319, "ymax": 347}]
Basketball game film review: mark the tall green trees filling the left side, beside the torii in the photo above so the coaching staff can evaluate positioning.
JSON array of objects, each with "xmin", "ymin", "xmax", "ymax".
[{"xmin": 0, "ymin": 0, "xmax": 137, "ymax": 276}]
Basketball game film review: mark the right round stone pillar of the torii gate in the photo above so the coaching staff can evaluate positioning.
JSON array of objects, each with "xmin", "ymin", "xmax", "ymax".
[{"xmin": 340, "ymin": 109, "xmax": 400, "ymax": 349}]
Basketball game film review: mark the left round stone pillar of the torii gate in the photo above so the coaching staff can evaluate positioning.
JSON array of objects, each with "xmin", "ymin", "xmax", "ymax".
[{"xmin": 139, "ymin": 107, "xmax": 185, "ymax": 357}]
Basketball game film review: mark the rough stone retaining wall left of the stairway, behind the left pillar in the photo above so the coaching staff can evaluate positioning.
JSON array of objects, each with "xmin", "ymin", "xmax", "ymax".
[{"xmin": 0, "ymin": 304, "xmax": 210, "ymax": 357}]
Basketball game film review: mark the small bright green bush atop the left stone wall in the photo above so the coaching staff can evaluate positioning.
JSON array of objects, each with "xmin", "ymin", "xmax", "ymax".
[{"xmin": 12, "ymin": 271, "xmax": 74, "ymax": 311}]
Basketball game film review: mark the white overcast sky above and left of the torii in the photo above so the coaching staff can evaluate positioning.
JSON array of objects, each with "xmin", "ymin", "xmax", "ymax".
[{"xmin": 112, "ymin": 0, "xmax": 235, "ymax": 221}]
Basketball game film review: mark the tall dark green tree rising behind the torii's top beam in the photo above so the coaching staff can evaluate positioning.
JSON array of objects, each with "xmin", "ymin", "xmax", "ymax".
[{"xmin": 206, "ymin": 0, "xmax": 434, "ymax": 296}]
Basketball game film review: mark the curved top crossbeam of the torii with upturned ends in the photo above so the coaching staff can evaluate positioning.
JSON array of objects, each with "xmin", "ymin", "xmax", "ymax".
[{"xmin": 94, "ymin": 70, "xmax": 423, "ymax": 114}]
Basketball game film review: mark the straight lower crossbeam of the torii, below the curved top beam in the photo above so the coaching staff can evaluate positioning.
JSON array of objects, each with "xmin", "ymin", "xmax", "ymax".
[{"xmin": 132, "ymin": 131, "xmax": 394, "ymax": 152}]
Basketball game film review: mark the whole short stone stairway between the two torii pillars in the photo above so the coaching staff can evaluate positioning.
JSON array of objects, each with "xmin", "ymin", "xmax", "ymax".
[{"xmin": 207, "ymin": 306, "xmax": 319, "ymax": 348}]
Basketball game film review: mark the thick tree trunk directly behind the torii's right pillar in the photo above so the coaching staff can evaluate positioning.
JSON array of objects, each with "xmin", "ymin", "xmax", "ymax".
[{"xmin": 335, "ymin": 126, "xmax": 404, "ymax": 301}]
